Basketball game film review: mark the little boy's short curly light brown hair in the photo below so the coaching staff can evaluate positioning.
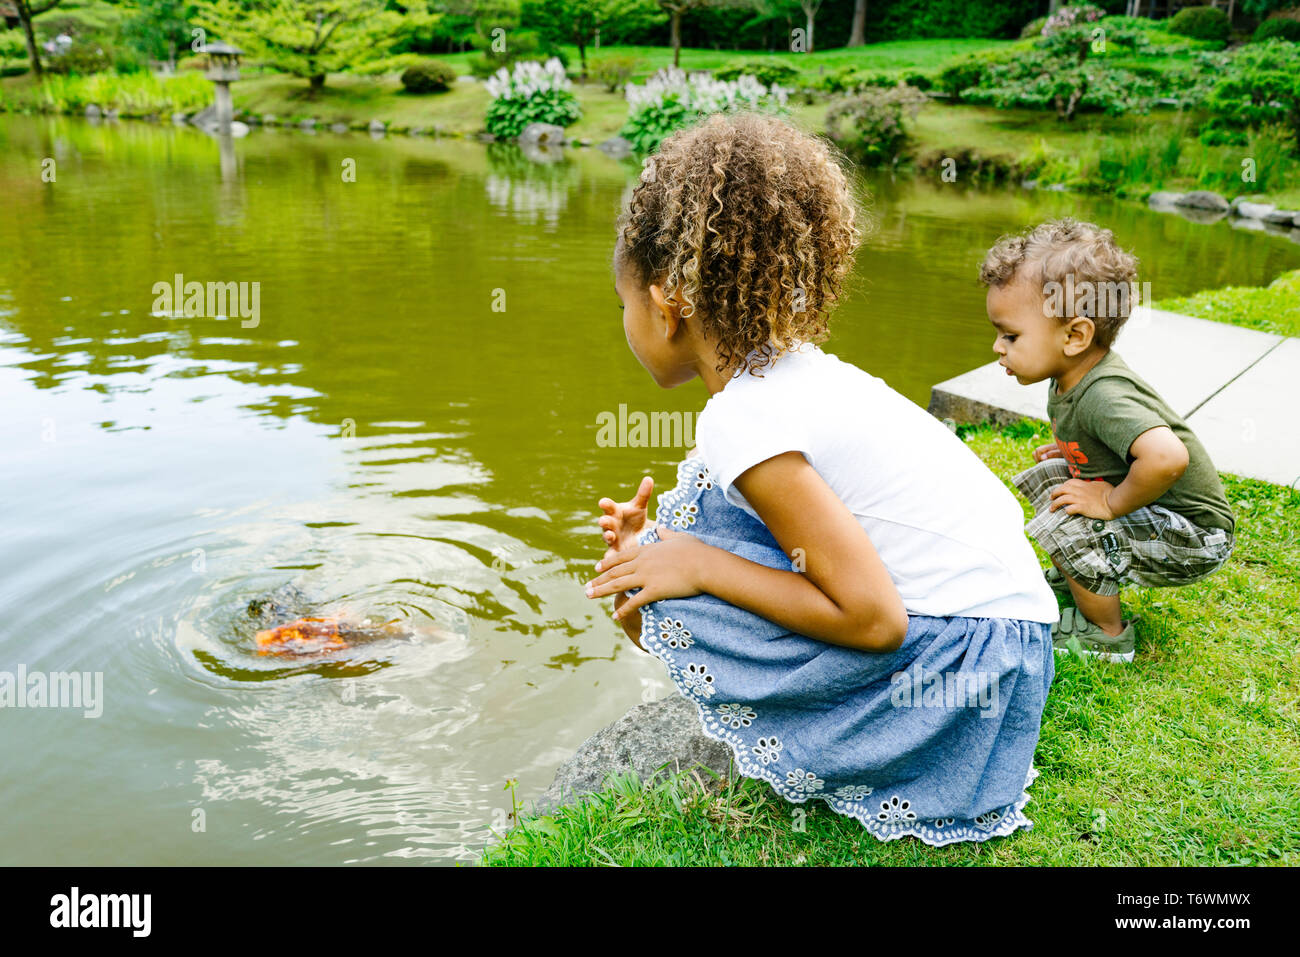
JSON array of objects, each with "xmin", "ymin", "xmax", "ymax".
[{"xmin": 979, "ymin": 216, "xmax": 1138, "ymax": 348}]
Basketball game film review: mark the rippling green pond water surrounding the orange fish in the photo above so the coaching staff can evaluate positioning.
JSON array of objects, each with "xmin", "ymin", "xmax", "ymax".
[{"xmin": 0, "ymin": 117, "xmax": 1300, "ymax": 865}]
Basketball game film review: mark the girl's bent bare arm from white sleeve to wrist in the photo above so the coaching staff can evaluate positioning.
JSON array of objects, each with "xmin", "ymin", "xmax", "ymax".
[{"xmin": 702, "ymin": 451, "xmax": 907, "ymax": 651}]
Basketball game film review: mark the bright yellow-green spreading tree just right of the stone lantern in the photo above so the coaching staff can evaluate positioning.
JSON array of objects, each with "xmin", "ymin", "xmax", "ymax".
[{"xmin": 194, "ymin": 0, "xmax": 432, "ymax": 96}]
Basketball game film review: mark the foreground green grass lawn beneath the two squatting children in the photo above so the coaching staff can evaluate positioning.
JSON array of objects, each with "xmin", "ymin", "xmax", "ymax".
[{"xmin": 484, "ymin": 423, "xmax": 1300, "ymax": 866}]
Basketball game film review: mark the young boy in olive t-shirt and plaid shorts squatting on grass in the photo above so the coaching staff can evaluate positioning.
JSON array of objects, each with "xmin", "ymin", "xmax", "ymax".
[{"xmin": 980, "ymin": 218, "xmax": 1235, "ymax": 662}]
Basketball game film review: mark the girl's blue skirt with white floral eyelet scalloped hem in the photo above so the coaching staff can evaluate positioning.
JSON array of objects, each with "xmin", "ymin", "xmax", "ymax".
[{"xmin": 640, "ymin": 458, "xmax": 1054, "ymax": 846}]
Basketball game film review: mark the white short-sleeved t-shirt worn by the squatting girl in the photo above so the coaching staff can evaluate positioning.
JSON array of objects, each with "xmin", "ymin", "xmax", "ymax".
[{"xmin": 696, "ymin": 343, "xmax": 1058, "ymax": 623}]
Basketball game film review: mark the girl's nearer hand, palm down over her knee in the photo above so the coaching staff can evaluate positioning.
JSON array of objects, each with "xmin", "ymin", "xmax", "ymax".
[{"xmin": 586, "ymin": 525, "xmax": 712, "ymax": 619}]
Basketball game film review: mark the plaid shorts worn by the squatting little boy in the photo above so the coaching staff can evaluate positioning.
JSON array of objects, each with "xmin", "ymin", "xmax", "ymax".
[{"xmin": 1011, "ymin": 458, "xmax": 1234, "ymax": 594}]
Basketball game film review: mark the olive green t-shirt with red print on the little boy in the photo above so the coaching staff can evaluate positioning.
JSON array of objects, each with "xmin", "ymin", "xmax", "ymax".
[{"xmin": 1048, "ymin": 351, "xmax": 1236, "ymax": 532}]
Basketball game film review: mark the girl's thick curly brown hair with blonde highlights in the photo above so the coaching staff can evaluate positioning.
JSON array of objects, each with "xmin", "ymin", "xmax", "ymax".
[{"xmin": 615, "ymin": 113, "xmax": 862, "ymax": 374}]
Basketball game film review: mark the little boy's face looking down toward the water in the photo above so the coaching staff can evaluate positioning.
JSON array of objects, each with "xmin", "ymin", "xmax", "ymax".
[{"xmin": 985, "ymin": 277, "xmax": 1075, "ymax": 385}]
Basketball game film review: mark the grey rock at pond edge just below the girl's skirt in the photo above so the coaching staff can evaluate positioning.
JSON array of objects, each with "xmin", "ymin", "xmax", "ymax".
[{"xmin": 536, "ymin": 693, "xmax": 735, "ymax": 814}]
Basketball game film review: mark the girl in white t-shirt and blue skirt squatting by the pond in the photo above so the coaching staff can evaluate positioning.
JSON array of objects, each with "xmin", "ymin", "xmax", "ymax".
[{"xmin": 586, "ymin": 114, "xmax": 1057, "ymax": 845}]
